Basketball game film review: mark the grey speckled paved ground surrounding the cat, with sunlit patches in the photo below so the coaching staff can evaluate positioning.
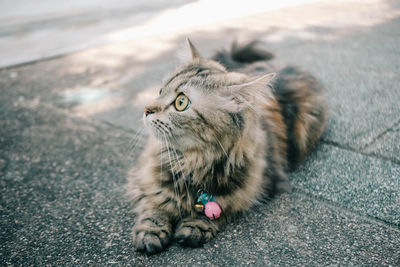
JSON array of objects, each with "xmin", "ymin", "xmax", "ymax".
[{"xmin": 0, "ymin": 0, "xmax": 400, "ymax": 266}]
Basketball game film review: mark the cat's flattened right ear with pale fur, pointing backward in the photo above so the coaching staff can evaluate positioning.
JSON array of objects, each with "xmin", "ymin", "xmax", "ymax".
[{"xmin": 224, "ymin": 73, "xmax": 276, "ymax": 112}]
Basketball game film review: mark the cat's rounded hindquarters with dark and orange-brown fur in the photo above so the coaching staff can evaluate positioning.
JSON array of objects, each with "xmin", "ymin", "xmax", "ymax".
[{"xmin": 272, "ymin": 66, "xmax": 327, "ymax": 169}]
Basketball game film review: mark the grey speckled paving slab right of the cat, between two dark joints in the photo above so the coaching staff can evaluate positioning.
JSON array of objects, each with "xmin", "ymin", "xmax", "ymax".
[{"xmin": 291, "ymin": 144, "xmax": 400, "ymax": 226}]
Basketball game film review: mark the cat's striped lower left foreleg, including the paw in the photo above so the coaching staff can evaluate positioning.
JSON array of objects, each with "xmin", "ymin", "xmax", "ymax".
[{"xmin": 133, "ymin": 211, "xmax": 172, "ymax": 254}]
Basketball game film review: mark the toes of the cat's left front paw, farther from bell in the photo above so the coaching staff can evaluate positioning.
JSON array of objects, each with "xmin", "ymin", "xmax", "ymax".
[{"xmin": 133, "ymin": 227, "xmax": 170, "ymax": 254}]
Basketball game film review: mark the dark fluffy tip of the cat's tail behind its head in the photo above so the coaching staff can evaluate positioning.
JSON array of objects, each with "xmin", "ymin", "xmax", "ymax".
[{"xmin": 212, "ymin": 41, "xmax": 274, "ymax": 70}]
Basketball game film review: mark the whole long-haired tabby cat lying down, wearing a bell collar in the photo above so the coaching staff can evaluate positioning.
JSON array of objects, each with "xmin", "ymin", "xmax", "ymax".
[{"xmin": 128, "ymin": 39, "xmax": 326, "ymax": 254}]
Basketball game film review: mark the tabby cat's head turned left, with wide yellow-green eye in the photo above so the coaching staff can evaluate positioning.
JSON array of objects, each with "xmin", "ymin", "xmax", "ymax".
[{"xmin": 144, "ymin": 40, "xmax": 274, "ymax": 150}]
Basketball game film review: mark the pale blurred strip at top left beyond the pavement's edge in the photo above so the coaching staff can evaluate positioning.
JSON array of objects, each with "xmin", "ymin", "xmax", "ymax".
[{"xmin": 0, "ymin": 0, "xmax": 324, "ymax": 67}]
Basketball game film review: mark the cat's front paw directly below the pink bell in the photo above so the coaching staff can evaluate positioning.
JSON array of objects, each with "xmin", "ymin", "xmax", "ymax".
[{"xmin": 174, "ymin": 218, "xmax": 217, "ymax": 247}]
